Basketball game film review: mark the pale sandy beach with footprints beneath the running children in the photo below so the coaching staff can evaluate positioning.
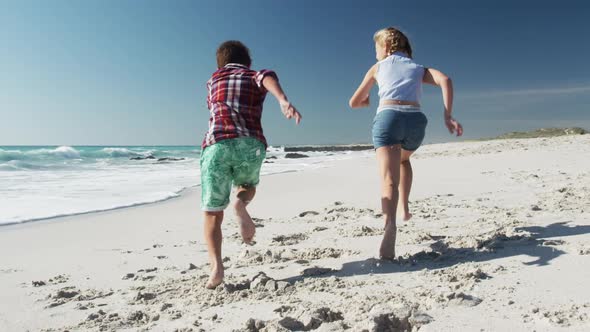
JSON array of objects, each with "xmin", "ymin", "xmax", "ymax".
[{"xmin": 0, "ymin": 135, "xmax": 590, "ymax": 331}]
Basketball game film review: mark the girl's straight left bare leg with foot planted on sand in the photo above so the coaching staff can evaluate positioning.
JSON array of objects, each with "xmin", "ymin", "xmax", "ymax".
[{"xmin": 377, "ymin": 144, "xmax": 401, "ymax": 259}]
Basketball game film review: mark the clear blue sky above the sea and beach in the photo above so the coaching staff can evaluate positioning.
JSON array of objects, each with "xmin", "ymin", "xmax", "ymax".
[{"xmin": 0, "ymin": 0, "xmax": 590, "ymax": 145}]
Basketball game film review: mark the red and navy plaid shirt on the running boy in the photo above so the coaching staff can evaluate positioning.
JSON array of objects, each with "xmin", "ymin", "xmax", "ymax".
[{"xmin": 202, "ymin": 63, "xmax": 277, "ymax": 149}]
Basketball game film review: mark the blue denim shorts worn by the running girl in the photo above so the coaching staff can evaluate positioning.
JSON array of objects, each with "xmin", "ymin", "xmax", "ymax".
[{"xmin": 373, "ymin": 109, "xmax": 428, "ymax": 151}]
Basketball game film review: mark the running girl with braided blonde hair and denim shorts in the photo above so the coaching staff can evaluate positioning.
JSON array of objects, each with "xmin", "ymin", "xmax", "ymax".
[{"xmin": 349, "ymin": 27, "xmax": 463, "ymax": 259}]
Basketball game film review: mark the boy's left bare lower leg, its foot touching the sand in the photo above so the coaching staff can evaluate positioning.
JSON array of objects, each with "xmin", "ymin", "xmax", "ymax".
[{"xmin": 205, "ymin": 211, "xmax": 223, "ymax": 289}]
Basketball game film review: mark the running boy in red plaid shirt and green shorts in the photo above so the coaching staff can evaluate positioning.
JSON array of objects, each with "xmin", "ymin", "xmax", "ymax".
[{"xmin": 200, "ymin": 40, "xmax": 301, "ymax": 289}]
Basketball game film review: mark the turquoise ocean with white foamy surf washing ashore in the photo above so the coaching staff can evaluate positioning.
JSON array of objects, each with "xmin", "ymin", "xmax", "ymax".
[{"xmin": 0, "ymin": 146, "xmax": 367, "ymax": 226}]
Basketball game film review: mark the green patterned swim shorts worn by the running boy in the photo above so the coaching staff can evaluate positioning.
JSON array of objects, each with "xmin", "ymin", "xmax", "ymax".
[{"xmin": 200, "ymin": 137, "xmax": 266, "ymax": 211}]
